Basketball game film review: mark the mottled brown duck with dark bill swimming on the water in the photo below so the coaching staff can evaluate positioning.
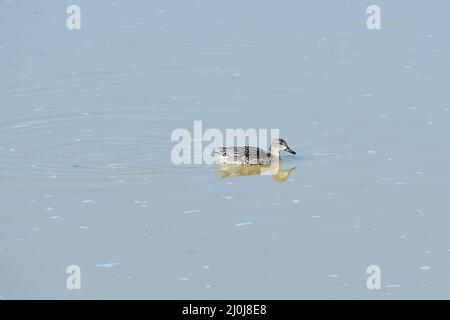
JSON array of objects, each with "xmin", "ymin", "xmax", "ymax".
[{"xmin": 214, "ymin": 138, "xmax": 296, "ymax": 165}]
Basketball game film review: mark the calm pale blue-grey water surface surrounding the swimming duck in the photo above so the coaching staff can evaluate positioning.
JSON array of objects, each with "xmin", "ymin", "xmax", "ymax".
[{"xmin": 0, "ymin": 0, "xmax": 450, "ymax": 299}]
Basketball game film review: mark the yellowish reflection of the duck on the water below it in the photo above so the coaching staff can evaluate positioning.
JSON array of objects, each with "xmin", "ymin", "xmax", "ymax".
[{"xmin": 218, "ymin": 161, "xmax": 296, "ymax": 182}]
